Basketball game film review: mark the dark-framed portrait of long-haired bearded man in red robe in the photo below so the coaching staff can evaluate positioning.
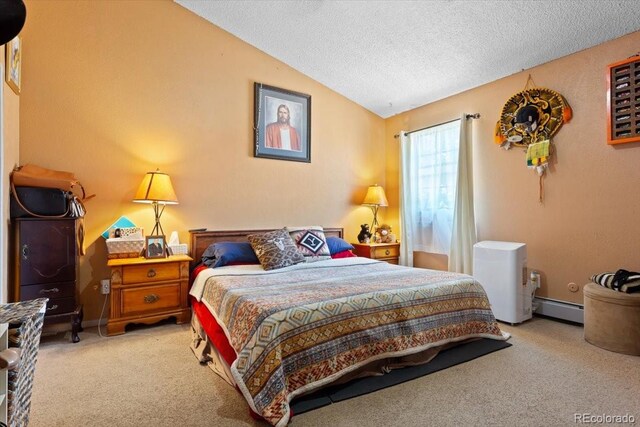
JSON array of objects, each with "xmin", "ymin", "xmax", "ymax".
[{"xmin": 254, "ymin": 83, "xmax": 311, "ymax": 163}]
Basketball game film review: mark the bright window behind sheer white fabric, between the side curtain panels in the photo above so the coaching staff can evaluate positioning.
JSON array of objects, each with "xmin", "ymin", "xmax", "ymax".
[{"xmin": 403, "ymin": 120, "xmax": 460, "ymax": 254}]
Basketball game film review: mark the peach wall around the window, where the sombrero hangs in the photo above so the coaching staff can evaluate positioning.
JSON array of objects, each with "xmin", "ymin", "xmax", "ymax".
[{"xmin": 385, "ymin": 32, "xmax": 640, "ymax": 303}]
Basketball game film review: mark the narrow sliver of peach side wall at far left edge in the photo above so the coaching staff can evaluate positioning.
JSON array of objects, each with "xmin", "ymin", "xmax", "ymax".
[{"xmin": 0, "ymin": 45, "xmax": 20, "ymax": 303}]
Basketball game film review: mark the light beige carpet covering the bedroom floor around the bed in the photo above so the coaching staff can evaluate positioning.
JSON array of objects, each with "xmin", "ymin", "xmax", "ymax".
[{"xmin": 30, "ymin": 318, "xmax": 640, "ymax": 427}]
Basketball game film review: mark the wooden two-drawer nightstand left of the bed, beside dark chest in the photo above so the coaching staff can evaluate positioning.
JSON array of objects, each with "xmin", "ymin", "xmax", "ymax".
[{"xmin": 107, "ymin": 255, "xmax": 192, "ymax": 335}]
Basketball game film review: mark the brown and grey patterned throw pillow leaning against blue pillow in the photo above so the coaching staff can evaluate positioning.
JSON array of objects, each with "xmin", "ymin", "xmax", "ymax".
[{"xmin": 247, "ymin": 228, "xmax": 304, "ymax": 270}]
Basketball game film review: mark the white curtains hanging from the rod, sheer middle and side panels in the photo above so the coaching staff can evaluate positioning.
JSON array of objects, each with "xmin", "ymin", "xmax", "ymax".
[{"xmin": 400, "ymin": 114, "xmax": 475, "ymax": 271}]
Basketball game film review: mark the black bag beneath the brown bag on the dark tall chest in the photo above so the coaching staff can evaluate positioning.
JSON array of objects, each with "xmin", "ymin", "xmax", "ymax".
[{"xmin": 10, "ymin": 186, "xmax": 69, "ymax": 218}]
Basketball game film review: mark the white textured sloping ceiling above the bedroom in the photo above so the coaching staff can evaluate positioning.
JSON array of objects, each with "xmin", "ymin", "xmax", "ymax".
[{"xmin": 175, "ymin": 0, "xmax": 640, "ymax": 118}]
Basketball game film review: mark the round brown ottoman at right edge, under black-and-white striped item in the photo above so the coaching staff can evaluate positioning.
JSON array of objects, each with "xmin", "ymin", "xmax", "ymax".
[{"xmin": 584, "ymin": 283, "xmax": 640, "ymax": 356}]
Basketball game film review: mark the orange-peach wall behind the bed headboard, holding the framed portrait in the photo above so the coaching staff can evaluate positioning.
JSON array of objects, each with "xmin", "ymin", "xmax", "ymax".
[{"xmin": 20, "ymin": 1, "xmax": 385, "ymax": 319}]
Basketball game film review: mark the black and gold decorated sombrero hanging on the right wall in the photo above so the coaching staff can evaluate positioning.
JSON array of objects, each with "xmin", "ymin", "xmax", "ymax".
[{"xmin": 494, "ymin": 76, "xmax": 573, "ymax": 202}]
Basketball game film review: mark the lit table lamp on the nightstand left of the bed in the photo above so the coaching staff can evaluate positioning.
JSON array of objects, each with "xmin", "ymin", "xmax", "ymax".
[{"xmin": 133, "ymin": 169, "xmax": 178, "ymax": 236}]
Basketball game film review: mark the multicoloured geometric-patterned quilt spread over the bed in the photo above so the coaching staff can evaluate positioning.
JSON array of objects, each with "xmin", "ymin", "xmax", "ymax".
[{"xmin": 191, "ymin": 258, "xmax": 508, "ymax": 426}]
